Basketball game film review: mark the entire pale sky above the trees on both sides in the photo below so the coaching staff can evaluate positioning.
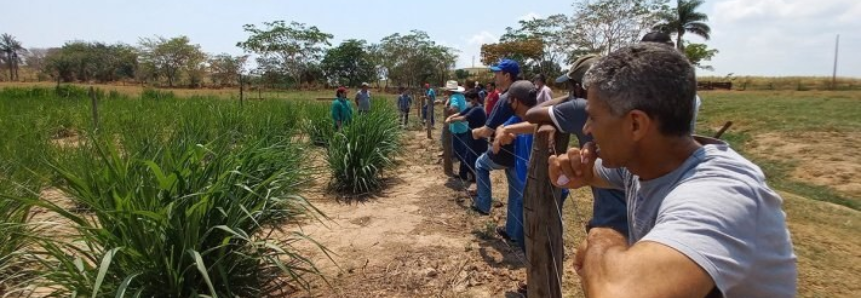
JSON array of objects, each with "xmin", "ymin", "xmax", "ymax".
[{"xmin": 0, "ymin": 0, "xmax": 861, "ymax": 77}]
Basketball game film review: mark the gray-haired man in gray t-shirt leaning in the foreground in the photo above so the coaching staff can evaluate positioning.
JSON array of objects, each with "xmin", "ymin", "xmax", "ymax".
[{"xmin": 549, "ymin": 43, "xmax": 797, "ymax": 298}]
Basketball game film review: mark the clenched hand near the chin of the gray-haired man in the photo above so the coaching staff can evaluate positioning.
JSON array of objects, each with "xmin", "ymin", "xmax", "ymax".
[{"xmin": 548, "ymin": 143, "xmax": 598, "ymax": 189}]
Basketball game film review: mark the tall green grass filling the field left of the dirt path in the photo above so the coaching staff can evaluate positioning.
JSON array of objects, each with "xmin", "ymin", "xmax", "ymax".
[{"xmin": 0, "ymin": 86, "xmax": 358, "ymax": 297}]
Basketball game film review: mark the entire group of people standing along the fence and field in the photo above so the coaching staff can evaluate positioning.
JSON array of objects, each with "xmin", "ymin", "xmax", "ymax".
[{"xmin": 333, "ymin": 33, "xmax": 797, "ymax": 298}]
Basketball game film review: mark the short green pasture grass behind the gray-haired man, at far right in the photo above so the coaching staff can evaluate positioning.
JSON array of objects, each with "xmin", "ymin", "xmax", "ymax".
[{"xmin": 697, "ymin": 92, "xmax": 861, "ymax": 210}]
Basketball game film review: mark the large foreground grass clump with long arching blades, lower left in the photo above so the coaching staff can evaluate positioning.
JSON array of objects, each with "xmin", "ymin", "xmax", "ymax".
[{"xmin": 21, "ymin": 138, "xmax": 325, "ymax": 297}]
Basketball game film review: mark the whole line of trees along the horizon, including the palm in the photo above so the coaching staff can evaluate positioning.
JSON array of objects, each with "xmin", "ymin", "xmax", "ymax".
[{"xmin": 0, "ymin": 0, "xmax": 717, "ymax": 88}]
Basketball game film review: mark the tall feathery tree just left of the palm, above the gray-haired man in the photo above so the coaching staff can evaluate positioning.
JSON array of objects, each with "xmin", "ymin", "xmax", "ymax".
[{"xmin": 563, "ymin": 0, "xmax": 669, "ymax": 58}]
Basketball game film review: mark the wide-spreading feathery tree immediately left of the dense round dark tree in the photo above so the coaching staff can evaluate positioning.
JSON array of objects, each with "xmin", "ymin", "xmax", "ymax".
[{"xmin": 236, "ymin": 21, "xmax": 333, "ymax": 87}]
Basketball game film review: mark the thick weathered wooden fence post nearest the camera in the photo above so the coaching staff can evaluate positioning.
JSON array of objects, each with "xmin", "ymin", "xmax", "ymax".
[{"xmin": 523, "ymin": 125, "xmax": 570, "ymax": 298}]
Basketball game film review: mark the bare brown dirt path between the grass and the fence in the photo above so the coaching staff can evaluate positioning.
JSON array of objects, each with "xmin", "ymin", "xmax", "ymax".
[{"xmin": 298, "ymin": 131, "xmax": 536, "ymax": 297}]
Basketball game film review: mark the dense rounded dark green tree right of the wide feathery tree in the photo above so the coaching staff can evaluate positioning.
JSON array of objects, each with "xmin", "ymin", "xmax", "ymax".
[{"xmin": 321, "ymin": 39, "xmax": 376, "ymax": 87}]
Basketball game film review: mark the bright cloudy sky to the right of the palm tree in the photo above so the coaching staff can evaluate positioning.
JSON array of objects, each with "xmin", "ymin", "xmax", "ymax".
[{"xmin": 700, "ymin": 0, "xmax": 861, "ymax": 76}]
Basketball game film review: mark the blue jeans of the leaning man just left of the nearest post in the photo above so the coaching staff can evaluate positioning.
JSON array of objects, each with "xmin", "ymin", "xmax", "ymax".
[{"xmin": 475, "ymin": 153, "xmax": 525, "ymax": 245}]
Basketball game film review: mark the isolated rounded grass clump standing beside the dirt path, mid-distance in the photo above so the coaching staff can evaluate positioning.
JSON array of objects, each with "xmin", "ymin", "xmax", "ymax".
[{"xmin": 328, "ymin": 108, "xmax": 401, "ymax": 195}]
